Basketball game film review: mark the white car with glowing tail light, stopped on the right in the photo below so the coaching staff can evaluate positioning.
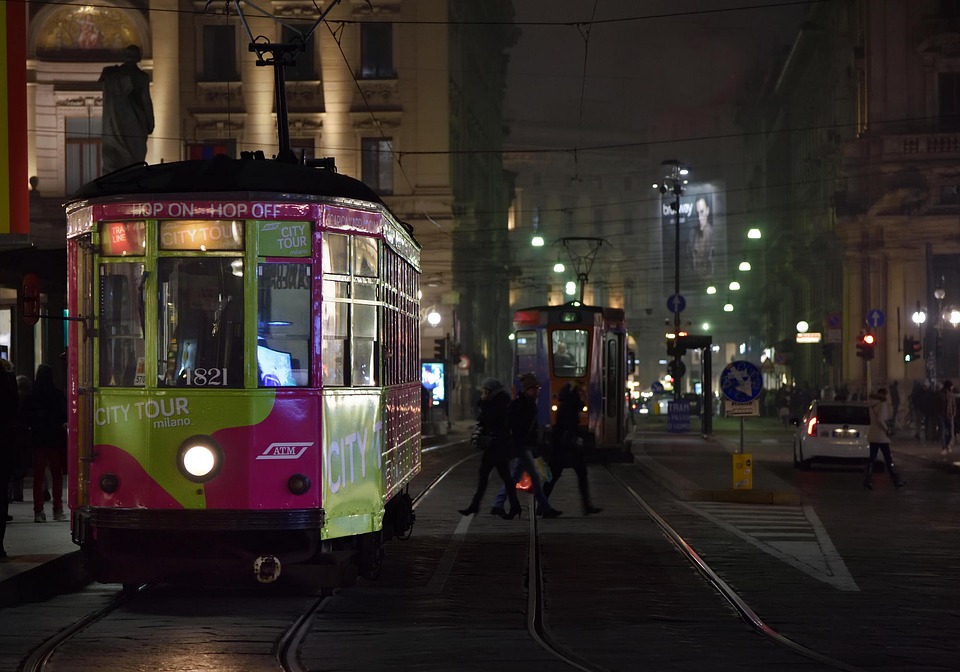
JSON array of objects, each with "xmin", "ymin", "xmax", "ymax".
[{"xmin": 793, "ymin": 401, "xmax": 870, "ymax": 469}]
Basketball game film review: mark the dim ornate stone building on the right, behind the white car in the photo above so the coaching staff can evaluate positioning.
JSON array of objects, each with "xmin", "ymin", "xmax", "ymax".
[{"xmin": 741, "ymin": 0, "xmax": 960, "ymax": 397}]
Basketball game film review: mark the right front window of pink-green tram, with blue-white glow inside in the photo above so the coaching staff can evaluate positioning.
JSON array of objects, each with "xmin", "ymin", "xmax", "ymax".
[{"xmin": 257, "ymin": 263, "xmax": 311, "ymax": 387}]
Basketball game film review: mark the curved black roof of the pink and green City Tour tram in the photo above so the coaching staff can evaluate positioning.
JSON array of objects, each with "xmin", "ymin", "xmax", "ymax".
[{"xmin": 68, "ymin": 156, "xmax": 386, "ymax": 207}]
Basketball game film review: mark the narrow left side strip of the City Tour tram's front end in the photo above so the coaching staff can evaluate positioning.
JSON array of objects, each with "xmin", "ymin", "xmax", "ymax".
[{"xmin": 70, "ymin": 234, "xmax": 95, "ymax": 506}]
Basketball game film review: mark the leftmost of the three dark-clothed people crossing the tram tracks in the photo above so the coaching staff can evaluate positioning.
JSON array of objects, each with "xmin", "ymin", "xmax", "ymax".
[{"xmin": 458, "ymin": 378, "xmax": 520, "ymax": 518}]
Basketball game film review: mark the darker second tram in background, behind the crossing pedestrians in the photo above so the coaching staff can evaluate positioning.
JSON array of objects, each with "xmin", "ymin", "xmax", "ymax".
[{"xmin": 513, "ymin": 301, "xmax": 630, "ymax": 459}]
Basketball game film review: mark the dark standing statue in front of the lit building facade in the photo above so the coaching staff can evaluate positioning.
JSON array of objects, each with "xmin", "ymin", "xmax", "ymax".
[{"xmin": 100, "ymin": 45, "xmax": 153, "ymax": 174}]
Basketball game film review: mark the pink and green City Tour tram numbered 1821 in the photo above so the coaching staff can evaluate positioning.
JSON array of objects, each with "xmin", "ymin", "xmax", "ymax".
[{"xmin": 61, "ymin": 155, "xmax": 420, "ymax": 586}]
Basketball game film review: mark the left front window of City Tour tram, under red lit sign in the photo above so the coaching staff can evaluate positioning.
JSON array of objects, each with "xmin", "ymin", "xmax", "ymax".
[{"xmin": 99, "ymin": 264, "xmax": 146, "ymax": 387}]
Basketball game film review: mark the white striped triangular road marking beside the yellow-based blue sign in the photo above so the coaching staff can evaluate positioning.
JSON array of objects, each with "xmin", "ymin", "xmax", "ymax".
[{"xmin": 679, "ymin": 502, "xmax": 860, "ymax": 591}]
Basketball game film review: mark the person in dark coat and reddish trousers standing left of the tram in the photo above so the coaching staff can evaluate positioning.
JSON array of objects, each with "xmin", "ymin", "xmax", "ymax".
[{"xmin": 24, "ymin": 364, "xmax": 67, "ymax": 523}]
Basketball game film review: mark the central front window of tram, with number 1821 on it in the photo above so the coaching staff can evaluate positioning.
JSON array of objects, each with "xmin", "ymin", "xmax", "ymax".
[{"xmin": 157, "ymin": 257, "xmax": 243, "ymax": 387}]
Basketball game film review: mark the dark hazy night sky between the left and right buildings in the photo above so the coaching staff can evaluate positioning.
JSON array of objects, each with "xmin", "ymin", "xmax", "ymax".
[{"xmin": 505, "ymin": 0, "xmax": 809, "ymax": 184}]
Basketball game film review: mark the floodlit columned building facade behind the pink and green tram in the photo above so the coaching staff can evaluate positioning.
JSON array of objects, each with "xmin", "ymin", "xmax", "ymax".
[{"xmin": 0, "ymin": 0, "xmax": 512, "ymax": 414}]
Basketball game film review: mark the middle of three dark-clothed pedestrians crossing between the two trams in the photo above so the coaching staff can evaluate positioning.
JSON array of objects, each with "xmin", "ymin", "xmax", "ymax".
[{"xmin": 490, "ymin": 373, "xmax": 562, "ymax": 518}]
